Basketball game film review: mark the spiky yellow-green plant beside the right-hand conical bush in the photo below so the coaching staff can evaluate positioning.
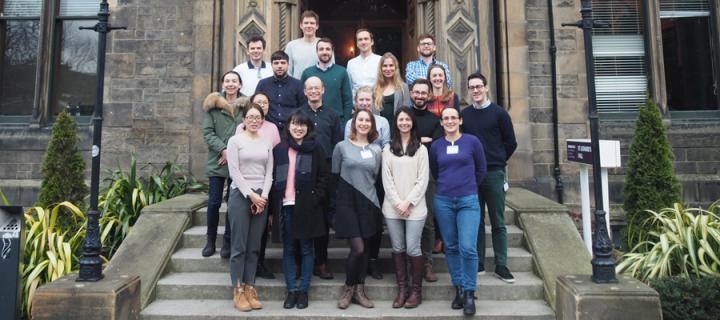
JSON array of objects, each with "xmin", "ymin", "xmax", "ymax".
[{"xmin": 617, "ymin": 202, "xmax": 720, "ymax": 282}]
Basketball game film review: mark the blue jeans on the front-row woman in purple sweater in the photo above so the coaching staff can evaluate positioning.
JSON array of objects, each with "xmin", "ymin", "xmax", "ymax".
[{"xmin": 435, "ymin": 194, "xmax": 480, "ymax": 291}]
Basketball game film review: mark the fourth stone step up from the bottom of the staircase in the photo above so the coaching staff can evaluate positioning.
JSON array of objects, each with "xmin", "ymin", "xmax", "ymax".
[{"xmin": 182, "ymin": 225, "xmax": 523, "ymax": 248}]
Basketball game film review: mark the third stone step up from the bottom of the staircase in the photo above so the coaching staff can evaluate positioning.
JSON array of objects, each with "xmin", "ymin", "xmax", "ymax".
[{"xmin": 169, "ymin": 247, "xmax": 533, "ymax": 274}]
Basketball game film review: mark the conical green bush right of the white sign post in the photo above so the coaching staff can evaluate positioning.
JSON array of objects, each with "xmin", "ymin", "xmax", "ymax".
[{"xmin": 623, "ymin": 98, "xmax": 680, "ymax": 250}]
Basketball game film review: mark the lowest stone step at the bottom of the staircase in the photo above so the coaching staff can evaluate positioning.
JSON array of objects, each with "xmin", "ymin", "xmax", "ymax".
[{"xmin": 141, "ymin": 299, "xmax": 555, "ymax": 320}]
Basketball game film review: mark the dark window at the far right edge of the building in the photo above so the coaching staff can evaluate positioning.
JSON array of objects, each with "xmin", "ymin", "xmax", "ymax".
[{"xmin": 660, "ymin": 0, "xmax": 718, "ymax": 111}]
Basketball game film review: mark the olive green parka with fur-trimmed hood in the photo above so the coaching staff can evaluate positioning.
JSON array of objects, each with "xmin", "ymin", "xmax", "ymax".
[{"xmin": 202, "ymin": 92, "xmax": 248, "ymax": 177}]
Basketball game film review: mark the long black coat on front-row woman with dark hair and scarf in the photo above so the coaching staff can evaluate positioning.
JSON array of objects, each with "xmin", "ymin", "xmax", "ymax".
[{"xmin": 270, "ymin": 140, "xmax": 330, "ymax": 242}]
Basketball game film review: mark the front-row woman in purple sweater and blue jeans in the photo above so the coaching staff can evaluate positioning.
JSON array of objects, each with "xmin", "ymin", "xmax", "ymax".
[{"xmin": 430, "ymin": 108, "xmax": 487, "ymax": 316}]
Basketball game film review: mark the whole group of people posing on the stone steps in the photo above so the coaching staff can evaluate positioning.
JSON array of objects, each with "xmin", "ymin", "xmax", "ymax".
[{"xmin": 202, "ymin": 11, "xmax": 517, "ymax": 315}]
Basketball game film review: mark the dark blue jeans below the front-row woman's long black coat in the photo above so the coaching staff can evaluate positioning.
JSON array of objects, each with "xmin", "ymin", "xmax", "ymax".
[{"xmin": 281, "ymin": 206, "xmax": 315, "ymax": 292}]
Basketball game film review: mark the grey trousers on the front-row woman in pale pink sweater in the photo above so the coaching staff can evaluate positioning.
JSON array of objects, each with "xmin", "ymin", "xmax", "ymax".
[{"xmin": 228, "ymin": 189, "xmax": 267, "ymax": 287}]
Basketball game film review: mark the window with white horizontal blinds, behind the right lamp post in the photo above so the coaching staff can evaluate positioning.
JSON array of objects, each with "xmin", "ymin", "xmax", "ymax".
[{"xmin": 592, "ymin": 0, "xmax": 648, "ymax": 113}]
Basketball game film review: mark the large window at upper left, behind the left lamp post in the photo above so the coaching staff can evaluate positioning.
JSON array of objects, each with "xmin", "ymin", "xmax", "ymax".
[{"xmin": 0, "ymin": 0, "xmax": 100, "ymax": 125}]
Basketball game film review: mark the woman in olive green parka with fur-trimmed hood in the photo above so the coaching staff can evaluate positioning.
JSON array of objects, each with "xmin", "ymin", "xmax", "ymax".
[{"xmin": 202, "ymin": 71, "xmax": 247, "ymax": 258}]
